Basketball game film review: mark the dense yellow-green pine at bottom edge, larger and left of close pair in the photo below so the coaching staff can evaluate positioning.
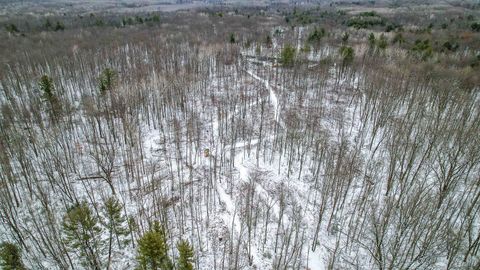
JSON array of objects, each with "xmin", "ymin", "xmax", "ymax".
[{"xmin": 137, "ymin": 222, "xmax": 173, "ymax": 270}]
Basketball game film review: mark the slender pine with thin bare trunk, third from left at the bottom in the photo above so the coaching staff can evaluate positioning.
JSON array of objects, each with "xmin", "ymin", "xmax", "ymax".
[{"xmin": 103, "ymin": 197, "xmax": 129, "ymax": 268}]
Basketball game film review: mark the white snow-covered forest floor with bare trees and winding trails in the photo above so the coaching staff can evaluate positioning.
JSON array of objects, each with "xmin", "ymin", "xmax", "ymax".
[{"xmin": 0, "ymin": 32, "xmax": 478, "ymax": 270}]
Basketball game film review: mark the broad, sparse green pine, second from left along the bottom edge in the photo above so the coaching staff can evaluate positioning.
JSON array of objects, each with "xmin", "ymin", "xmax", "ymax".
[{"xmin": 63, "ymin": 202, "xmax": 101, "ymax": 270}]
